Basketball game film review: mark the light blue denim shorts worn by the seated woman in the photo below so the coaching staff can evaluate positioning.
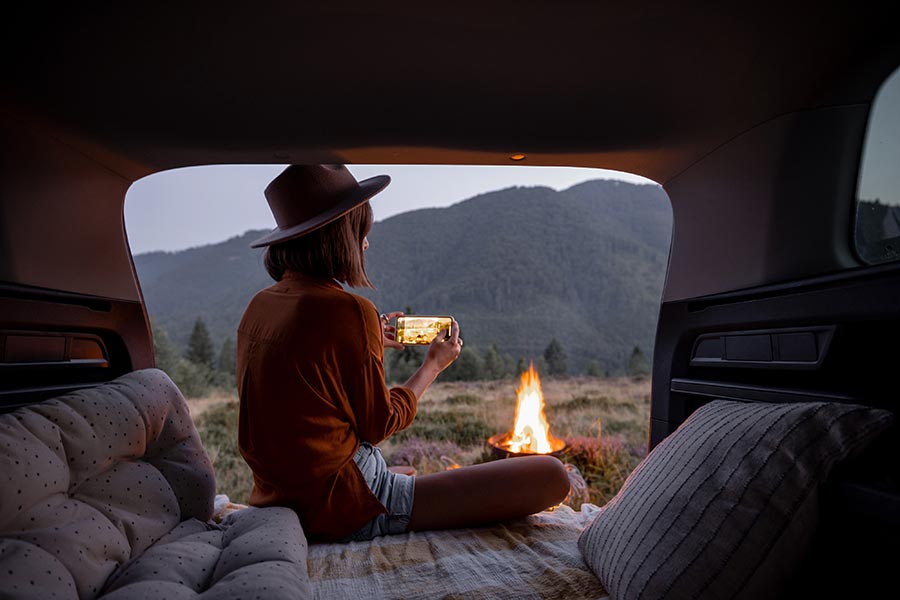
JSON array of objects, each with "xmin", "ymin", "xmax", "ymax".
[{"xmin": 341, "ymin": 442, "xmax": 416, "ymax": 542}]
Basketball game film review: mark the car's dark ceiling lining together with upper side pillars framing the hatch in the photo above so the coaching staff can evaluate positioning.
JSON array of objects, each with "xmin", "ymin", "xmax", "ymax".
[{"xmin": 0, "ymin": 1, "xmax": 900, "ymax": 302}]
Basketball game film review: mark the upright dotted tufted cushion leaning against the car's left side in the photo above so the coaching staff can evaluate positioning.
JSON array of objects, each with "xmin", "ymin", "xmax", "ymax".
[{"xmin": 0, "ymin": 369, "xmax": 215, "ymax": 598}]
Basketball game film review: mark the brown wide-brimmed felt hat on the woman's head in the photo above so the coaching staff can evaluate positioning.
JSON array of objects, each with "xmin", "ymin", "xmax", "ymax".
[{"xmin": 250, "ymin": 165, "xmax": 391, "ymax": 248}]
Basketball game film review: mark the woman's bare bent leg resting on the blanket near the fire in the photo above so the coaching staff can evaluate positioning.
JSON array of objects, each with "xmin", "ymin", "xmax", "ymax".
[{"xmin": 409, "ymin": 456, "xmax": 569, "ymax": 531}]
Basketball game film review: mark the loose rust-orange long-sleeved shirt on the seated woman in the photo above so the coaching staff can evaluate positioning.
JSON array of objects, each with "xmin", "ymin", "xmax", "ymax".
[{"xmin": 237, "ymin": 271, "xmax": 416, "ymax": 540}]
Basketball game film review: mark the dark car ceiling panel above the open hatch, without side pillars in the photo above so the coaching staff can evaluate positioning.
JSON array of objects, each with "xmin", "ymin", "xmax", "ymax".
[{"xmin": 4, "ymin": 1, "xmax": 900, "ymax": 183}]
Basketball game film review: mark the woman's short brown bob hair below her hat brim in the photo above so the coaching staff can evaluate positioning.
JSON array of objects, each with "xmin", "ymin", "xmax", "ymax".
[{"xmin": 263, "ymin": 202, "xmax": 375, "ymax": 288}]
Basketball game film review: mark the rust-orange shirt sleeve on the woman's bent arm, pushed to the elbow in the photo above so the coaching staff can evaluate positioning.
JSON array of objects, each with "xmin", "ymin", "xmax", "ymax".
[{"xmin": 347, "ymin": 299, "xmax": 417, "ymax": 444}]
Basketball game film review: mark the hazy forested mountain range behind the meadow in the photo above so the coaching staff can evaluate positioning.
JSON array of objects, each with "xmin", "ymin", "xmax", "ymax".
[{"xmin": 135, "ymin": 180, "xmax": 672, "ymax": 372}]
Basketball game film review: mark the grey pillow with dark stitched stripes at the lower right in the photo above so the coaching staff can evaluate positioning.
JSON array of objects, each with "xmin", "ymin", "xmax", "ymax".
[{"xmin": 578, "ymin": 400, "xmax": 891, "ymax": 600}]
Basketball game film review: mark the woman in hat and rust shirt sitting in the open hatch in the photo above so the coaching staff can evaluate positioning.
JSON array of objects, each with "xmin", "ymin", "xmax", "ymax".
[{"xmin": 237, "ymin": 165, "xmax": 569, "ymax": 541}]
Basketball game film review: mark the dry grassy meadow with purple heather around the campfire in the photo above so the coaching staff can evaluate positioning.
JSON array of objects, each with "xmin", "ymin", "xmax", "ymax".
[{"xmin": 188, "ymin": 377, "xmax": 650, "ymax": 506}]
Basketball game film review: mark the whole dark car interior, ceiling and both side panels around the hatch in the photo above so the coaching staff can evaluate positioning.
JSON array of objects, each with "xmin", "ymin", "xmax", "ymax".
[{"xmin": 0, "ymin": 1, "xmax": 900, "ymax": 597}]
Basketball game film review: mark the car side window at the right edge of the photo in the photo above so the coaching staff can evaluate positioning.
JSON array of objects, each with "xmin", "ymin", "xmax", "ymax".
[{"xmin": 855, "ymin": 63, "xmax": 900, "ymax": 264}]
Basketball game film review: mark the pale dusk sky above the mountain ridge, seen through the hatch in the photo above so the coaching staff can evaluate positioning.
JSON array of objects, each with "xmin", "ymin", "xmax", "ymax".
[{"xmin": 125, "ymin": 165, "xmax": 653, "ymax": 254}]
